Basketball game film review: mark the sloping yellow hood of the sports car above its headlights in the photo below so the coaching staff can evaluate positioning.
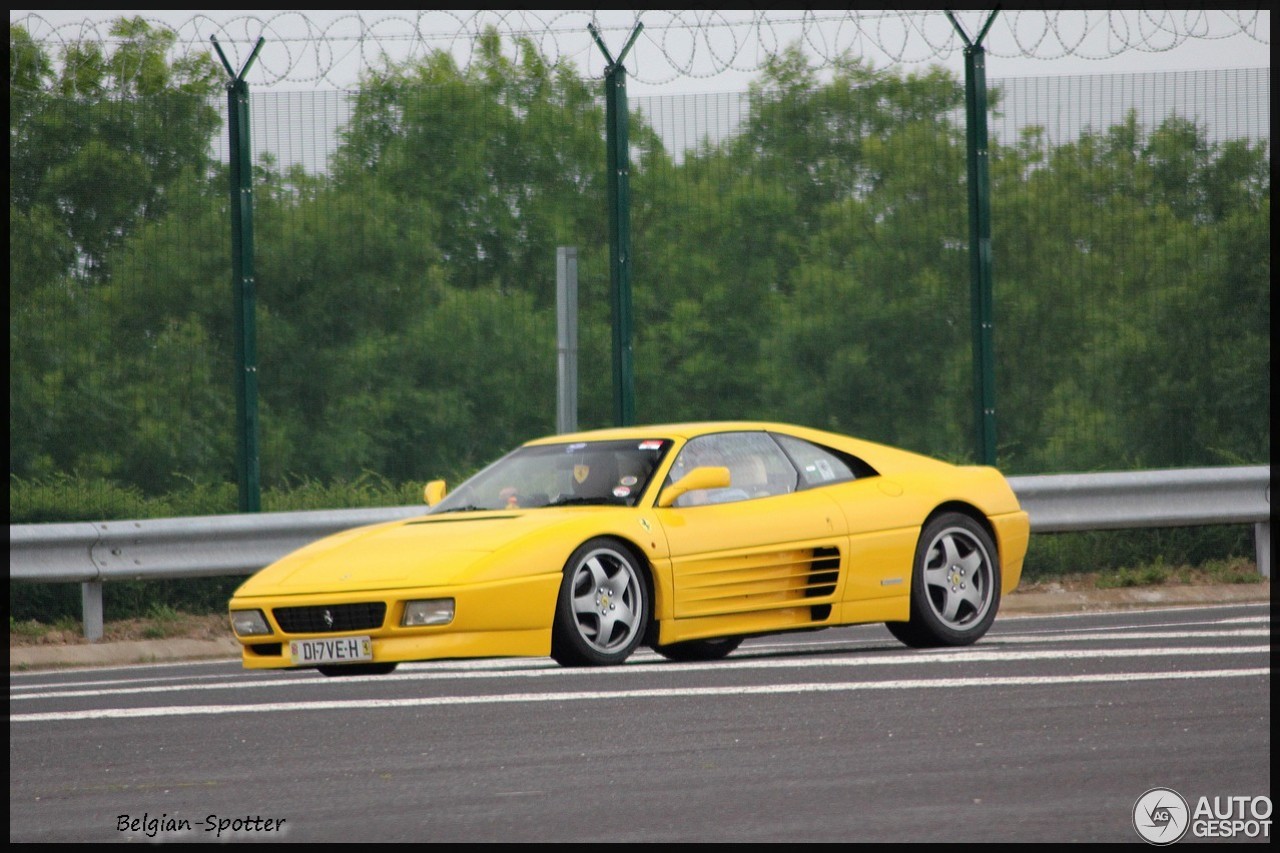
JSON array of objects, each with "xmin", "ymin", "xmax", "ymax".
[{"xmin": 236, "ymin": 510, "xmax": 581, "ymax": 597}]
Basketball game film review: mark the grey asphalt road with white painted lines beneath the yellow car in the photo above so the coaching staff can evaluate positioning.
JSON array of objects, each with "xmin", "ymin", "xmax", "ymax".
[{"xmin": 9, "ymin": 603, "xmax": 1271, "ymax": 843}]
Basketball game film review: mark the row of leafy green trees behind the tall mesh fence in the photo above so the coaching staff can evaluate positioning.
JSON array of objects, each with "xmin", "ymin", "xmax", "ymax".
[{"xmin": 10, "ymin": 20, "xmax": 1270, "ymax": 517}]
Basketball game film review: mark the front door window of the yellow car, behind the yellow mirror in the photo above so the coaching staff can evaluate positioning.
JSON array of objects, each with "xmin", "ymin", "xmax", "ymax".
[{"xmin": 667, "ymin": 432, "xmax": 799, "ymax": 506}]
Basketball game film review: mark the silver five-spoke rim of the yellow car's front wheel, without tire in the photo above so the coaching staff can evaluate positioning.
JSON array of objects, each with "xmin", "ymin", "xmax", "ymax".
[{"xmin": 570, "ymin": 547, "xmax": 644, "ymax": 654}]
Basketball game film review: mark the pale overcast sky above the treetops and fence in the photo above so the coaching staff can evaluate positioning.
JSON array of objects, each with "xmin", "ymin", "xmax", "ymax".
[{"xmin": 9, "ymin": 9, "xmax": 1271, "ymax": 96}]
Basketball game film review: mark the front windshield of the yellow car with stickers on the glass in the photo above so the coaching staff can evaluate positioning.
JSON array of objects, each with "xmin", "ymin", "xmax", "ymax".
[{"xmin": 431, "ymin": 438, "xmax": 671, "ymax": 515}]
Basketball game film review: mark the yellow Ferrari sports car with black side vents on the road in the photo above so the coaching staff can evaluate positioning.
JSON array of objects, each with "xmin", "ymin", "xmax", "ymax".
[{"xmin": 230, "ymin": 423, "xmax": 1029, "ymax": 675}]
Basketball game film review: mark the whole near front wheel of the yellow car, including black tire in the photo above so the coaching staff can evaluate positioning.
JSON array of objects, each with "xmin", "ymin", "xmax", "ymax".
[{"xmin": 552, "ymin": 538, "xmax": 650, "ymax": 666}]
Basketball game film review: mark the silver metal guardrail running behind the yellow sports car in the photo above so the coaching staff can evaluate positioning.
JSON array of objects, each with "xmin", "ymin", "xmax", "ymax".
[{"xmin": 9, "ymin": 465, "xmax": 1271, "ymax": 639}]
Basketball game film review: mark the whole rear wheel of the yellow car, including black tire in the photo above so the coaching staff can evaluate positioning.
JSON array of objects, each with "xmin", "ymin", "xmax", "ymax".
[{"xmin": 886, "ymin": 512, "xmax": 1000, "ymax": 648}]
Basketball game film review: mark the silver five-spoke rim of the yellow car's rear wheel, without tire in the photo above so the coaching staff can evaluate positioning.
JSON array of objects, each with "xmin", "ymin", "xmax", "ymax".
[{"xmin": 924, "ymin": 526, "xmax": 996, "ymax": 630}]
